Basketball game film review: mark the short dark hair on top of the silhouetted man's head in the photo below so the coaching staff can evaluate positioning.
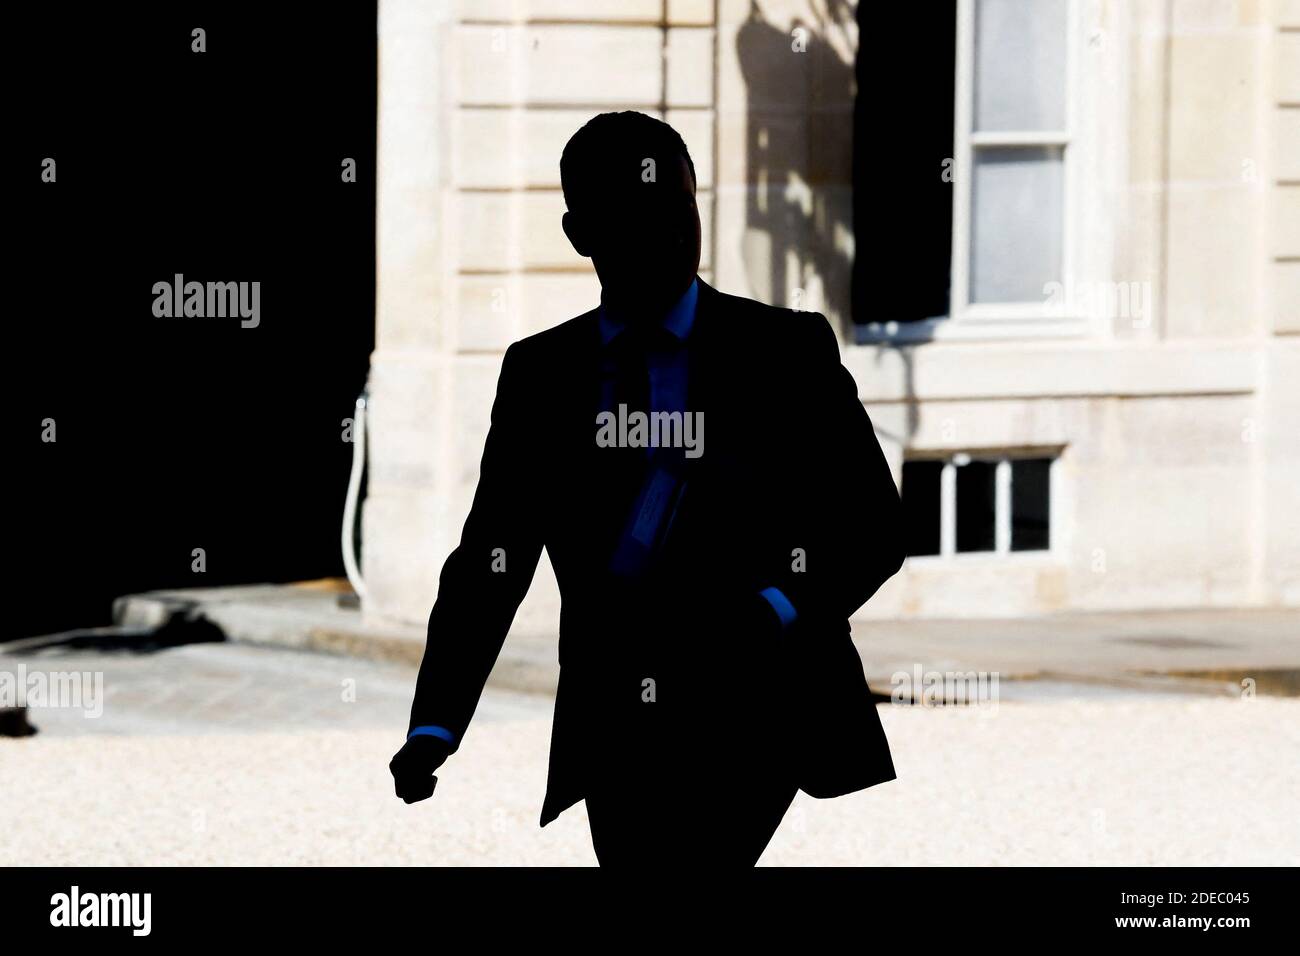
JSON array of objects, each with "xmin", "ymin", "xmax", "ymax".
[{"xmin": 560, "ymin": 109, "xmax": 696, "ymax": 211}]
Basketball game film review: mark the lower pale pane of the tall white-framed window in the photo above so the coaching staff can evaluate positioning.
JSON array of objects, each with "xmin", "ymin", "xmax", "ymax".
[{"xmin": 970, "ymin": 146, "xmax": 1065, "ymax": 302}]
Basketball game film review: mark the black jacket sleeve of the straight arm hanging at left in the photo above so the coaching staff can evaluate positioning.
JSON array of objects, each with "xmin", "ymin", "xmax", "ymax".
[{"xmin": 407, "ymin": 345, "xmax": 542, "ymax": 752}]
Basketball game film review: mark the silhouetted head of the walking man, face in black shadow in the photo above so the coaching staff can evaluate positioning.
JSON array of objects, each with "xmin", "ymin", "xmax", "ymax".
[{"xmin": 560, "ymin": 111, "xmax": 699, "ymax": 317}]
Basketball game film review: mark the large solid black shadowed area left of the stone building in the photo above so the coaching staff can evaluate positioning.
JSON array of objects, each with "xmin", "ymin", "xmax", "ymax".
[{"xmin": 8, "ymin": 3, "xmax": 377, "ymax": 639}]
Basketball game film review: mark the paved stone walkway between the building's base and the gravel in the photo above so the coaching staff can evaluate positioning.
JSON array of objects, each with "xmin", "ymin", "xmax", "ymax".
[{"xmin": 96, "ymin": 585, "xmax": 1300, "ymax": 695}]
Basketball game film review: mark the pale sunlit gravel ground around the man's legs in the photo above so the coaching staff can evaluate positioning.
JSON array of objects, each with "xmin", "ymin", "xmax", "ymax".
[{"xmin": 0, "ymin": 691, "xmax": 1300, "ymax": 866}]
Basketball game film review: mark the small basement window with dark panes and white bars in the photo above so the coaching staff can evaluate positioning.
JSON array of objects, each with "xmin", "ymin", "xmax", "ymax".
[{"xmin": 902, "ymin": 453, "xmax": 1057, "ymax": 557}]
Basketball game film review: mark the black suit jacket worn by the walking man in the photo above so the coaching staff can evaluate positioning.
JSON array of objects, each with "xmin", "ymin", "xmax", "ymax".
[{"xmin": 411, "ymin": 274, "xmax": 904, "ymax": 826}]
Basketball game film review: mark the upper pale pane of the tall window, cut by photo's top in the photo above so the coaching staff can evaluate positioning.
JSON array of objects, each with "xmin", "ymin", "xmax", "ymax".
[{"xmin": 975, "ymin": 0, "xmax": 1066, "ymax": 131}]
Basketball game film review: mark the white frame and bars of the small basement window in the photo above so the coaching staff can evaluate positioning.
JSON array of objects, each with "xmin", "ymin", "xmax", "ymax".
[{"xmin": 907, "ymin": 449, "xmax": 1062, "ymax": 562}]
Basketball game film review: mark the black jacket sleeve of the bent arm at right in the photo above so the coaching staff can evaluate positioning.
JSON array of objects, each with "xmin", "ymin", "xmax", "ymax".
[{"xmin": 771, "ymin": 312, "xmax": 905, "ymax": 629}]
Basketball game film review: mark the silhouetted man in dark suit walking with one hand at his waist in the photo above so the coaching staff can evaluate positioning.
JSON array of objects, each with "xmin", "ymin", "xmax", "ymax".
[{"xmin": 391, "ymin": 112, "xmax": 904, "ymax": 866}]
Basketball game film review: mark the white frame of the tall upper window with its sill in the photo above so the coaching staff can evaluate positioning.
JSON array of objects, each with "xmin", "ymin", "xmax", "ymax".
[{"xmin": 857, "ymin": 0, "xmax": 1096, "ymax": 345}]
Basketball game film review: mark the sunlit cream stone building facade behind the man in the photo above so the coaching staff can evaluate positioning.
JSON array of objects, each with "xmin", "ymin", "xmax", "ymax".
[{"xmin": 363, "ymin": 0, "xmax": 1300, "ymax": 632}]
